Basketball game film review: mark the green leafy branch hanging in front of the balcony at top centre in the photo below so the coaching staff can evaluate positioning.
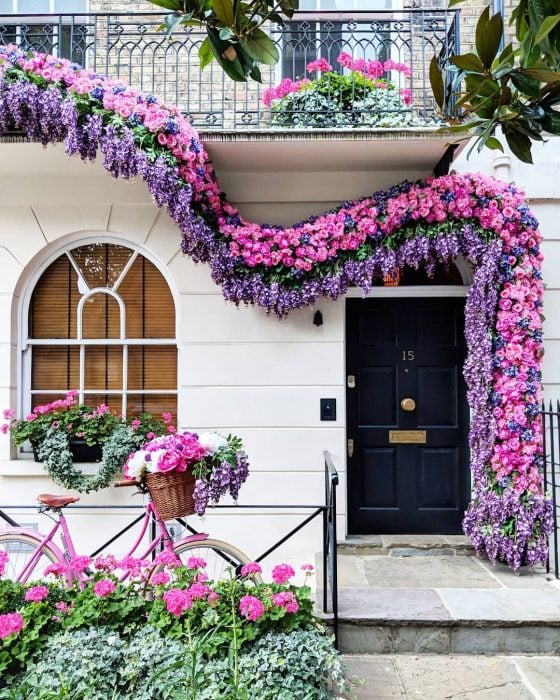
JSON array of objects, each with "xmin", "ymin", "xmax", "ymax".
[{"xmin": 150, "ymin": 0, "xmax": 299, "ymax": 82}]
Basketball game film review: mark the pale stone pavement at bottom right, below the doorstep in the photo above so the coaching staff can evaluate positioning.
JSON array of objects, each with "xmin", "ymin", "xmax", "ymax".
[{"xmin": 344, "ymin": 655, "xmax": 560, "ymax": 700}]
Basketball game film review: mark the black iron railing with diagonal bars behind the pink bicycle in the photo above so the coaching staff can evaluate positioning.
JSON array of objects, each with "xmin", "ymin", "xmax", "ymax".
[{"xmin": 0, "ymin": 452, "xmax": 338, "ymax": 648}]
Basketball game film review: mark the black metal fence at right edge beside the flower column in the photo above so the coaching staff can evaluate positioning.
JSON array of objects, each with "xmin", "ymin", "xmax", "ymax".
[{"xmin": 541, "ymin": 401, "xmax": 560, "ymax": 578}]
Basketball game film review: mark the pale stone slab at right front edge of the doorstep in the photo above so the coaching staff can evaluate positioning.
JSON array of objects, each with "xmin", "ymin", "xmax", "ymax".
[{"xmin": 438, "ymin": 588, "xmax": 560, "ymax": 620}]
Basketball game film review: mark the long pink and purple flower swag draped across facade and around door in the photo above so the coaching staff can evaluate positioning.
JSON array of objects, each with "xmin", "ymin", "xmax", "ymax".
[{"xmin": 0, "ymin": 47, "xmax": 552, "ymax": 570}]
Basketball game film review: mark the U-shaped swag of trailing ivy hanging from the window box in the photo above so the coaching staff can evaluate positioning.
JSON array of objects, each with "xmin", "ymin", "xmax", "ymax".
[{"xmin": 38, "ymin": 425, "xmax": 146, "ymax": 493}]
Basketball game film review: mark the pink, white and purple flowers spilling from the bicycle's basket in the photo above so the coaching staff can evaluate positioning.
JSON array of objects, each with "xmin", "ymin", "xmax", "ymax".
[{"xmin": 127, "ymin": 430, "xmax": 249, "ymax": 515}]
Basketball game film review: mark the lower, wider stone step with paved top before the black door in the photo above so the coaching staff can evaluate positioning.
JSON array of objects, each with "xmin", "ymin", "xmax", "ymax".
[{"xmin": 318, "ymin": 548, "xmax": 560, "ymax": 655}]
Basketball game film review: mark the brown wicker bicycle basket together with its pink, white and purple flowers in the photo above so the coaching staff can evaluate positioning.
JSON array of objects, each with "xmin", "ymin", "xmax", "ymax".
[{"xmin": 127, "ymin": 428, "xmax": 249, "ymax": 520}]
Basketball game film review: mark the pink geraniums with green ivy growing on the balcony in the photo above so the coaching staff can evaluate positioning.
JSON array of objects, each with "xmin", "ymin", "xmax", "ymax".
[{"xmin": 263, "ymin": 51, "xmax": 433, "ymax": 128}]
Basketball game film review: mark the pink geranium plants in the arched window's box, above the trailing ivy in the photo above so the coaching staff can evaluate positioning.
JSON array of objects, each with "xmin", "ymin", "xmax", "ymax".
[{"xmin": 0, "ymin": 390, "xmax": 120, "ymax": 446}]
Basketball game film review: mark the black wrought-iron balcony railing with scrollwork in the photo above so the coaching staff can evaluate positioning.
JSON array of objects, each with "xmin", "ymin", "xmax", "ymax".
[{"xmin": 0, "ymin": 9, "xmax": 459, "ymax": 130}]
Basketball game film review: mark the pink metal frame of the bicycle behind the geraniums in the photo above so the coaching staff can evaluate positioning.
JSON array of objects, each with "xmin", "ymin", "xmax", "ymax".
[{"xmin": 3, "ymin": 501, "xmax": 208, "ymax": 584}]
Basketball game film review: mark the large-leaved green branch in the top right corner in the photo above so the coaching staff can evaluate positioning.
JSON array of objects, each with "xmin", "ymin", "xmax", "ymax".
[{"xmin": 430, "ymin": 0, "xmax": 560, "ymax": 163}]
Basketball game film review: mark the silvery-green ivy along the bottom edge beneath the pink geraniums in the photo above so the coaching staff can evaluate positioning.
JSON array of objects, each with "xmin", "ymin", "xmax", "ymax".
[{"xmin": 4, "ymin": 626, "xmax": 349, "ymax": 700}]
